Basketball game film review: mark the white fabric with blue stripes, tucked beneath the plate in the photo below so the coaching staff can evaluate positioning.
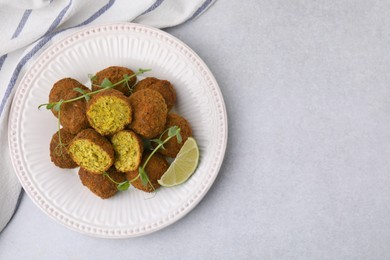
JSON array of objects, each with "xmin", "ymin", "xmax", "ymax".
[{"xmin": 0, "ymin": 0, "xmax": 215, "ymax": 231}]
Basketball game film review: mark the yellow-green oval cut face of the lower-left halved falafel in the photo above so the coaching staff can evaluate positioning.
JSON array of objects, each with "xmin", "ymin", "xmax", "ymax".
[{"xmin": 68, "ymin": 139, "xmax": 112, "ymax": 173}]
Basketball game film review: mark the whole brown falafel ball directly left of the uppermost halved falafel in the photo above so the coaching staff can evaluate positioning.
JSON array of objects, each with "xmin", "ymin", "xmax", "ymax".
[{"xmin": 60, "ymin": 91, "xmax": 89, "ymax": 134}]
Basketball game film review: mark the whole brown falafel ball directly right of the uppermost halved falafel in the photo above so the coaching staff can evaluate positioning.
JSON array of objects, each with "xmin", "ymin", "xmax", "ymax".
[{"xmin": 129, "ymin": 89, "xmax": 168, "ymax": 138}]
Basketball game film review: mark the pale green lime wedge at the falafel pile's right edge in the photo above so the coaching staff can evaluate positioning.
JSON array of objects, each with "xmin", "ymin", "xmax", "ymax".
[{"xmin": 158, "ymin": 137, "xmax": 199, "ymax": 187}]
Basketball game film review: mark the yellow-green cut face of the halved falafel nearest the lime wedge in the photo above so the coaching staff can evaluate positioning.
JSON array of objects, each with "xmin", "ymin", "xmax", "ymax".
[{"xmin": 111, "ymin": 131, "xmax": 142, "ymax": 172}]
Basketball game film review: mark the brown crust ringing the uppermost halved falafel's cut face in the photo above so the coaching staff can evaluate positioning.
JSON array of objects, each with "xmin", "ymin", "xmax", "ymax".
[{"xmin": 86, "ymin": 89, "xmax": 133, "ymax": 135}]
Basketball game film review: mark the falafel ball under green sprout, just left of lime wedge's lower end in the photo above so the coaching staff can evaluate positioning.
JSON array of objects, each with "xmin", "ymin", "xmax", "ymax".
[{"xmin": 126, "ymin": 152, "xmax": 169, "ymax": 192}]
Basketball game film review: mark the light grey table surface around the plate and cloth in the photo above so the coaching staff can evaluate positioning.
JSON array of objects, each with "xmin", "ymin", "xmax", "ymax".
[{"xmin": 0, "ymin": 0, "xmax": 390, "ymax": 259}]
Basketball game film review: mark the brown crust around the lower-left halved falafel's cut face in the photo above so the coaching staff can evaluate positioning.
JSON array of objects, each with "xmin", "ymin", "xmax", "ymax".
[{"xmin": 68, "ymin": 128, "xmax": 114, "ymax": 174}]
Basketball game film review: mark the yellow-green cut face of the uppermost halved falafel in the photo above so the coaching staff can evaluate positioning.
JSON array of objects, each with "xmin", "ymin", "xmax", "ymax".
[{"xmin": 87, "ymin": 96, "xmax": 131, "ymax": 135}]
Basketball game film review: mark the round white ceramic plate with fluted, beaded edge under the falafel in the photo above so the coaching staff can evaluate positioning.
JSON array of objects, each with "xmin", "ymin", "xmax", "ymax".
[{"xmin": 9, "ymin": 23, "xmax": 227, "ymax": 238}]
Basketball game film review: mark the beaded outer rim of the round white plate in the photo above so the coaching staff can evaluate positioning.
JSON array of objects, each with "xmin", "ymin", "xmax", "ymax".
[{"xmin": 8, "ymin": 22, "xmax": 228, "ymax": 238}]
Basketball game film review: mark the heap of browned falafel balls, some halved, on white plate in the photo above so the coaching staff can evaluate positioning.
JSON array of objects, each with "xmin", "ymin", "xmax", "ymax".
[{"xmin": 49, "ymin": 66, "xmax": 192, "ymax": 199}]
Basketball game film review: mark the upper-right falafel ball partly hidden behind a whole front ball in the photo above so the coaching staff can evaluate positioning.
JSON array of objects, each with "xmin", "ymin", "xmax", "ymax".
[{"xmin": 134, "ymin": 77, "xmax": 176, "ymax": 110}]
